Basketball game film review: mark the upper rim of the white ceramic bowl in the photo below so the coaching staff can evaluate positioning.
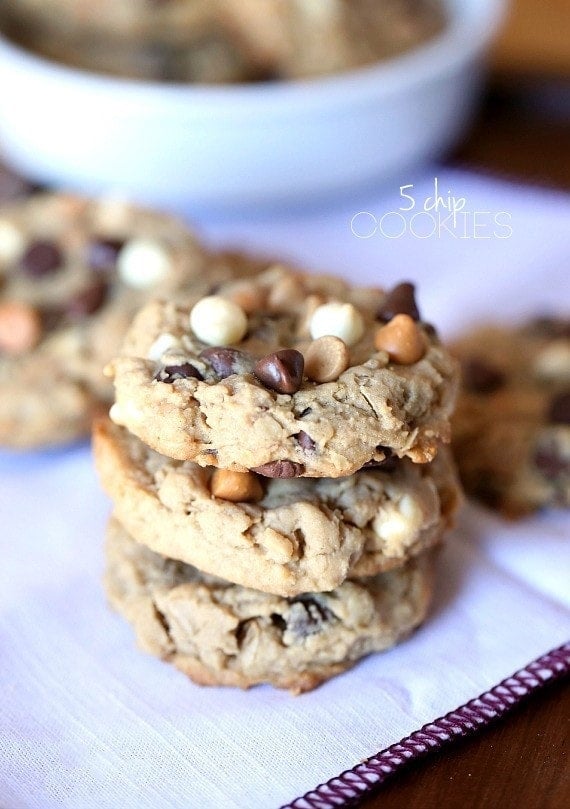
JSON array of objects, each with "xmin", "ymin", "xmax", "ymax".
[{"xmin": 0, "ymin": 0, "xmax": 508, "ymax": 117}]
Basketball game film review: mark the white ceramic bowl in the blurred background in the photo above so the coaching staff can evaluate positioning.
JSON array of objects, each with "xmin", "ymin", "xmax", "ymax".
[{"xmin": 0, "ymin": 0, "xmax": 504, "ymax": 211}]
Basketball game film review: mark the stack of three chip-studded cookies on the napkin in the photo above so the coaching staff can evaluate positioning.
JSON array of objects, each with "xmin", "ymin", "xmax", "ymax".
[{"xmin": 94, "ymin": 266, "xmax": 458, "ymax": 692}]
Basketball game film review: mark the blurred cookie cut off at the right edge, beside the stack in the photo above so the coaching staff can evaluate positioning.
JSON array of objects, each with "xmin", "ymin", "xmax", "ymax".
[{"xmin": 453, "ymin": 318, "xmax": 570, "ymax": 517}]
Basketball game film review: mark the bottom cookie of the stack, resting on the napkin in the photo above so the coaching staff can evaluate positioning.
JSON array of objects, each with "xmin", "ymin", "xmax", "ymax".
[{"xmin": 105, "ymin": 519, "xmax": 432, "ymax": 693}]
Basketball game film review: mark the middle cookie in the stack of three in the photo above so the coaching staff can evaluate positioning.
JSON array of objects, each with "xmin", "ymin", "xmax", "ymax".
[{"xmin": 94, "ymin": 420, "xmax": 459, "ymax": 596}]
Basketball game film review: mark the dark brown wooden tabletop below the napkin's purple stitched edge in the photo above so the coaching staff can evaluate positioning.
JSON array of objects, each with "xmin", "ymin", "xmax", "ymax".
[{"xmin": 356, "ymin": 679, "xmax": 570, "ymax": 809}]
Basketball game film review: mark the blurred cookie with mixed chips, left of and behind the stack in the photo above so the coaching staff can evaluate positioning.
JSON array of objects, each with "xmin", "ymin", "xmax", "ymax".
[{"xmin": 0, "ymin": 194, "xmax": 240, "ymax": 448}]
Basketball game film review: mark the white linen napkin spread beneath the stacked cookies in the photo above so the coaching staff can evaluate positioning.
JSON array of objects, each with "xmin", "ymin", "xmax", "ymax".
[{"xmin": 0, "ymin": 170, "xmax": 570, "ymax": 809}]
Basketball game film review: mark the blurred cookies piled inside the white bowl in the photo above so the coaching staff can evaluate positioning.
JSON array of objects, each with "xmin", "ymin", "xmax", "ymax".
[{"xmin": 3, "ymin": 0, "xmax": 446, "ymax": 83}]
